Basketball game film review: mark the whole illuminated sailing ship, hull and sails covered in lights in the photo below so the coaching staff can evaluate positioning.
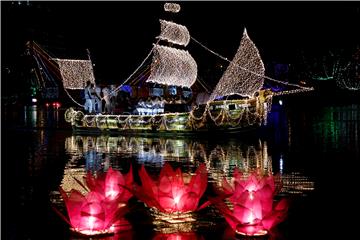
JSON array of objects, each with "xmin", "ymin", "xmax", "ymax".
[{"xmin": 57, "ymin": 4, "xmax": 272, "ymax": 134}]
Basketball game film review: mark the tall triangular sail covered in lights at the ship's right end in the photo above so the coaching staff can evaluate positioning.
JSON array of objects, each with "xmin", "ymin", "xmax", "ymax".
[{"xmin": 210, "ymin": 29, "xmax": 265, "ymax": 100}]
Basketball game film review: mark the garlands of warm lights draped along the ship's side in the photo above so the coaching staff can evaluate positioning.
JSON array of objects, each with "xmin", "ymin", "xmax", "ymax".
[{"xmin": 65, "ymin": 91, "xmax": 272, "ymax": 132}]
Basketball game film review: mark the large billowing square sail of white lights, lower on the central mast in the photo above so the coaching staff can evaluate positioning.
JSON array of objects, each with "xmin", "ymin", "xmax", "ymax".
[{"xmin": 146, "ymin": 44, "xmax": 197, "ymax": 88}]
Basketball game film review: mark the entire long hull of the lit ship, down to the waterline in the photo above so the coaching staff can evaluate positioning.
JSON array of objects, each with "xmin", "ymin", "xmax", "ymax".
[{"xmin": 65, "ymin": 91, "xmax": 272, "ymax": 135}]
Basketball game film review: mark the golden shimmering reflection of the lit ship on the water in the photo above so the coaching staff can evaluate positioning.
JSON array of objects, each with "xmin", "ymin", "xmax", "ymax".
[{"xmin": 65, "ymin": 135, "xmax": 314, "ymax": 194}]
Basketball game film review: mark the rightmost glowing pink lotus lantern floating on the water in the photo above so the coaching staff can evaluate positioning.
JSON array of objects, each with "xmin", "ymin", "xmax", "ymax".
[{"xmin": 215, "ymin": 169, "xmax": 288, "ymax": 236}]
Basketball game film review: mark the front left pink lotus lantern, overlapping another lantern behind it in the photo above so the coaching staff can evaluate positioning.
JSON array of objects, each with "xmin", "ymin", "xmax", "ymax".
[{"xmin": 57, "ymin": 187, "xmax": 128, "ymax": 235}]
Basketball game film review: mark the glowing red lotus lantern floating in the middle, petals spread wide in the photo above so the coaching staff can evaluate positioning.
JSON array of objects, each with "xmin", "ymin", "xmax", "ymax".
[{"xmin": 134, "ymin": 163, "xmax": 209, "ymax": 223}]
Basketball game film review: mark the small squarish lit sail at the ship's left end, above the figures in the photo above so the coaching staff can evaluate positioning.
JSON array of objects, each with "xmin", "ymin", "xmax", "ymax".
[{"xmin": 54, "ymin": 59, "xmax": 95, "ymax": 89}]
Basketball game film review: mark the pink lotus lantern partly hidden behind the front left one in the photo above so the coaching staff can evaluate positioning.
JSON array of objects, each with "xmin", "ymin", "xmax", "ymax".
[{"xmin": 85, "ymin": 165, "xmax": 133, "ymax": 203}]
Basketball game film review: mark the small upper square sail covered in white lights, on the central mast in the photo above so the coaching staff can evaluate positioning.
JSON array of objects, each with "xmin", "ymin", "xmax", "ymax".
[{"xmin": 158, "ymin": 19, "xmax": 190, "ymax": 46}]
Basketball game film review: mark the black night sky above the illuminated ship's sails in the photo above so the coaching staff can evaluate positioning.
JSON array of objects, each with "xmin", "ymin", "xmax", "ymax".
[{"xmin": 1, "ymin": 1, "xmax": 360, "ymax": 86}]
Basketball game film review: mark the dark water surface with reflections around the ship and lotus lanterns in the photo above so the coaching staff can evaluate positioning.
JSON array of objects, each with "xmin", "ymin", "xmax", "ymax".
[{"xmin": 1, "ymin": 96, "xmax": 360, "ymax": 240}]
